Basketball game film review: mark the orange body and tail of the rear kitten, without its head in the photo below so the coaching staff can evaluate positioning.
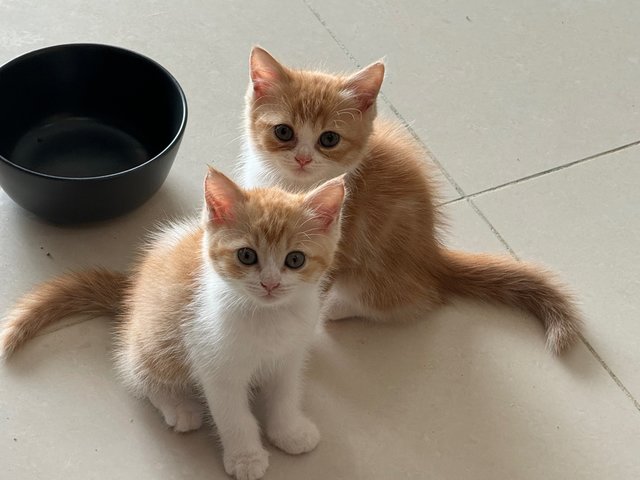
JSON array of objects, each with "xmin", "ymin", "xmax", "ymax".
[{"xmin": 333, "ymin": 120, "xmax": 582, "ymax": 353}]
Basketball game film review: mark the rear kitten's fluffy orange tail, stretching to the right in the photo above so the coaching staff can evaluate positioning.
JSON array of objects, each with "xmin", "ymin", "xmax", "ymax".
[{"xmin": 440, "ymin": 250, "xmax": 582, "ymax": 354}]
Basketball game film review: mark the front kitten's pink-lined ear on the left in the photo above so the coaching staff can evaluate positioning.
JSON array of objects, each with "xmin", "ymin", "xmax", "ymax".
[{"xmin": 204, "ymin": 167, "xmax": 244, "ymax": 225}]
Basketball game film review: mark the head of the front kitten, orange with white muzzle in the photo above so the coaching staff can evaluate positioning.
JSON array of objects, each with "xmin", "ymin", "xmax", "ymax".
[{"xmin": 204, "ymin": 168, "xmax": 345, "ymax": 305}]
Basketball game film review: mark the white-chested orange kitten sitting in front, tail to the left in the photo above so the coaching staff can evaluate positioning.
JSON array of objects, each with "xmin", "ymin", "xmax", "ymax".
[{"xmin": 0, "ymin": 169, "xmax": 345, "ymax": 480}]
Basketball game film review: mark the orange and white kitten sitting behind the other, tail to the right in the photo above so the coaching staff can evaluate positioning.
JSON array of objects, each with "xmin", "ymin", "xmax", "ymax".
[{"xmin": 239, "ymin": 47, "xmax": 581, "ymax": 353}]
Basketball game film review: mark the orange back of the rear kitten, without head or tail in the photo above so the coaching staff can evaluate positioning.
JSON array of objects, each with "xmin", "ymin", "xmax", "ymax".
[{"xmin": 337, "ymin": 120, "xmax": 448, "ymax": 310}]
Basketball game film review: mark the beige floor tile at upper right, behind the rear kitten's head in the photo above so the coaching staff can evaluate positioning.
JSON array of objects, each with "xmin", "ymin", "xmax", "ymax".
[{"xmin": 307, "ymin": 0, "xmax": 640, "ymax": 193}]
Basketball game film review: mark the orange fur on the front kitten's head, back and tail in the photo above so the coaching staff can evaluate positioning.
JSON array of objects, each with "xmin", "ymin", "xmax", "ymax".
[{"xmin": 0, "ymin": 166, "xmax": 343, "ymax": 382}]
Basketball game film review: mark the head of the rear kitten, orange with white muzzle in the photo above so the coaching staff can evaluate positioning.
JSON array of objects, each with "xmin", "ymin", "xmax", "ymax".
[{"xmin": 246, "ymin": 47, "xmax": 384, "ymax": 187}]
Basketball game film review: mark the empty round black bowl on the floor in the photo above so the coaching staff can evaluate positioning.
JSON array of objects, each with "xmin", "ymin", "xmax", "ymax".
[{"xmin": 0, "ymin": 44, "xmax": 187, "ymax": 223}]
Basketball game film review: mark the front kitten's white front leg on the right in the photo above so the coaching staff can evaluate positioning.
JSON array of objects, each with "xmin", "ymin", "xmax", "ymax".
[{"xmin": 262, "ymin": 352, "xmax": 320, "ymax": 455}]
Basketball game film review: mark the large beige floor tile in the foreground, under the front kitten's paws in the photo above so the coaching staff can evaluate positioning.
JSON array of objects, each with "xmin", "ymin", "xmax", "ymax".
[{"xmin": 0, "ymin": 303, "xmax": 640, "ymax": 480}]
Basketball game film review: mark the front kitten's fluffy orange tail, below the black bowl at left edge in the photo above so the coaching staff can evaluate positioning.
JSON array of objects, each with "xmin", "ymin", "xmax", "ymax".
[{"xmin": 0, "ymin": 269, "xmax": 129, "ymax": 357}]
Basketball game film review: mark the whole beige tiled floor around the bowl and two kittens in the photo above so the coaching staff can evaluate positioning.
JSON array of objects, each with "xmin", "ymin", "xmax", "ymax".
[{"xmin": 0, "ymin": 0, "xmax": 640, "ymax": 480}]
